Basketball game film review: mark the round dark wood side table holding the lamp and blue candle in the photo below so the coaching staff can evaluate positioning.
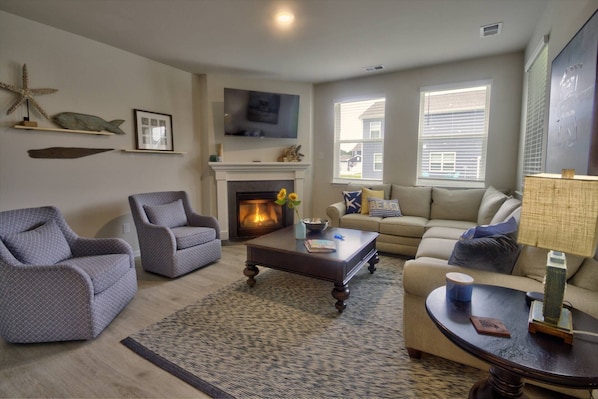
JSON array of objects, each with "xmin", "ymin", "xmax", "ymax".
[{"xmin": 426, "ymin": 285, "xmax": 598, "ymax": 398}]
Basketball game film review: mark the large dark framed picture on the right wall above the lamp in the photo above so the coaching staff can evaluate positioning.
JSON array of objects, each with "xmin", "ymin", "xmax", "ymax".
[{"xmin": 545, "ymin": 12, "xmax": 598, "ymax": 175}]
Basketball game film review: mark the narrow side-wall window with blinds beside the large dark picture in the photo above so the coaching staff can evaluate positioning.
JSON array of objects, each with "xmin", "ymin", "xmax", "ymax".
[{"xmin": 519, "ymin": 38, "xmax": 548, "ymax": 189}]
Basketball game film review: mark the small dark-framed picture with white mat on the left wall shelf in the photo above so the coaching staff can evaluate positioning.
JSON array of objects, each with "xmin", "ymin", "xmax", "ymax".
[{"xmin": 134, "ymin": 109, "xmax": 174, "ymax": 151}]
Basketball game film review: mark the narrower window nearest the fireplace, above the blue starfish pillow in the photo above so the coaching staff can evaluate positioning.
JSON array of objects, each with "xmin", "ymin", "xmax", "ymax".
[{"xmin": 334, "ymin": 98, "xmax": 386, "ymax": 182}]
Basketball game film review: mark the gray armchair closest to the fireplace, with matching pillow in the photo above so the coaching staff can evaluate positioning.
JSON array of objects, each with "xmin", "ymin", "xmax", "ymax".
[{"xmin": 129, "ymin": 191, "xmax": 222, "ymax": 278}]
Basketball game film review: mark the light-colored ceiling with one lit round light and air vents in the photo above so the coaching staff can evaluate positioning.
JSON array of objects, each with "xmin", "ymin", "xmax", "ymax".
[{"xmin": 0, "ymin": 0, "xmax": 550, "ymax": 83}]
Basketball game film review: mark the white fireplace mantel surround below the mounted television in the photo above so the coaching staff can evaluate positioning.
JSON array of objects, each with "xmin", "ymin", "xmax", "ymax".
[{"xmin": 209, "ymin": 162, "xmax": 311, "ymax": 240}]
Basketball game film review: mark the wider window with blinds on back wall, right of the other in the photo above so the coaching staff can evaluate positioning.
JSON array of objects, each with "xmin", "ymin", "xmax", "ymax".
[{"xmin": 417, "ymin": 82, "xmax": 490, "ymax": 187}]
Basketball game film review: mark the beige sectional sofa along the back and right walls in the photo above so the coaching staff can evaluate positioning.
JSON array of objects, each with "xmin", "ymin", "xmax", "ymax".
[{"xmin": 327, "ymin": 185, "xmax": 598, "ymax": 397}]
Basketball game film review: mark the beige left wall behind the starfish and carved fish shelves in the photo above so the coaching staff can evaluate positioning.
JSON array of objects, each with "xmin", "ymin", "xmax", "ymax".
[{"xmin": 0, "ymin": 11, "xmax": 202, "ymax": 249}]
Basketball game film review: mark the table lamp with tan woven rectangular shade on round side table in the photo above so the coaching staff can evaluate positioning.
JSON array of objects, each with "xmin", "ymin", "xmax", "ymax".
[{"xmin": 517, "ymin": 169, "xmax": 598, "ymax": 344}]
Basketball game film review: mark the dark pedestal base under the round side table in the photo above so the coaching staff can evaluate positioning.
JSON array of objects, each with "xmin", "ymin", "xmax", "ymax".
[{"xmin": 469, "ymin": 366, "xmax": 527, "ymax": 399}]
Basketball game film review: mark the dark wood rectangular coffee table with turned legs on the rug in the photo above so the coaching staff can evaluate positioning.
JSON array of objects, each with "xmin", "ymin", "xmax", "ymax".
[{"xmin": 243, "ymin": 226, "xmax": 379, "ymax": 312}]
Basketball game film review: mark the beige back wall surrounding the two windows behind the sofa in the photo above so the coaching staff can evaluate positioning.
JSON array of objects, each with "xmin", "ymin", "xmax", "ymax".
[{"xmin": 312, "ymin": 52, "xmax": 523, "ymax": 219}]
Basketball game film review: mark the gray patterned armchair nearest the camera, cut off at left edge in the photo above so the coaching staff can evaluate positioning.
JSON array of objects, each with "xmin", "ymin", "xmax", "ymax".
[{"xmin": 0, "ymin": 206, "xmax": 137, "ymax": 343}]
